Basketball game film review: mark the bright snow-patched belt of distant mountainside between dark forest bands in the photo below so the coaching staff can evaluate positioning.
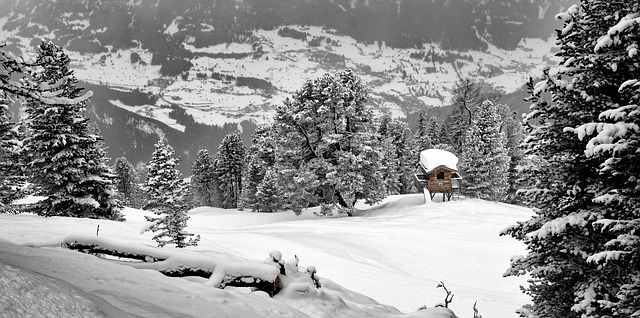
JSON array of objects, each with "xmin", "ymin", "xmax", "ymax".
[{"xmin": 0, "ymin": 21, "xmax": 552, "ymax": 127}]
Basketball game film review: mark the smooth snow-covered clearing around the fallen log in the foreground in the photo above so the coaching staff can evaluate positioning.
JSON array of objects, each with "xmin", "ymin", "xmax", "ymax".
[{"xmin": 0, "ymin": 195, "xmax": 532, "ymax": 318}]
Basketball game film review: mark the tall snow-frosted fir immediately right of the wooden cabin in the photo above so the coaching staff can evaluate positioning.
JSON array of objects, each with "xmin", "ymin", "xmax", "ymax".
[{"xmin": 461, "ymin": 100, "xmax": 509, "ymax": 201}]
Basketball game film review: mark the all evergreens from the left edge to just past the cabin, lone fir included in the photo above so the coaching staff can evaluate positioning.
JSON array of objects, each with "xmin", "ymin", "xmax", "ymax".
[{"xmin": 0, "ymin": 43, "xmax": 518, "ymax": 247}]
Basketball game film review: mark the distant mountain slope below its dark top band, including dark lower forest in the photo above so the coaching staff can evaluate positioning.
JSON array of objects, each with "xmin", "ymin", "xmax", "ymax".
[{"xmin": 0, "ymin": 22, "xmax": 551, "ymax": 174}]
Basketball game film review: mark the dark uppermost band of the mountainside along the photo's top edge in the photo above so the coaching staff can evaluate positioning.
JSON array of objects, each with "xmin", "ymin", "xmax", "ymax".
[{"xmin": 0, "ymin": 0, "xmax": 575, "ymax": 52}]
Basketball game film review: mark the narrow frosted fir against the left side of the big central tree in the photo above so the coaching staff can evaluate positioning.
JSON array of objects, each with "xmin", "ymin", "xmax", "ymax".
[{"xmin": 241, "ymin": 125, "xmax": 281, "ymax": 212}]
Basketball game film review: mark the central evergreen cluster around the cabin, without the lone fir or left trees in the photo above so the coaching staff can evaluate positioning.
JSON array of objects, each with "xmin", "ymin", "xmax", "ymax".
[{"xmin": 182, "ymin": 70, "xmax": 522, "ymax": 215}]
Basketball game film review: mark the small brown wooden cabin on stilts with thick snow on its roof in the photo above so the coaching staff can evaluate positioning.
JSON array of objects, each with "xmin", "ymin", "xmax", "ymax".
[{"xmin": 415, "ymin": 149, "xmax": 462, "ymax": 201}]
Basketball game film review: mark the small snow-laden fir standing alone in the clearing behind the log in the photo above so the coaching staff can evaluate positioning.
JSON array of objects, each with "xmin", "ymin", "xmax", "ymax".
[{"xmin": 143, "ymin": 140, "xmax": 200, "ymax": 248}]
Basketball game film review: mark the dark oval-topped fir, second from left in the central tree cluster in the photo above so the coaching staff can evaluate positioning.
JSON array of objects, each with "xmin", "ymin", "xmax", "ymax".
[{"xmin": 214, "ymin": 133, "xmax": 246, "ymax": 209}]
